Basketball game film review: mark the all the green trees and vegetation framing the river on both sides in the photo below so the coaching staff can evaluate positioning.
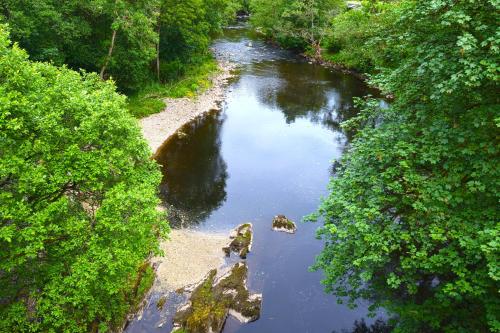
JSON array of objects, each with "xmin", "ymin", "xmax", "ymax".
[{"xmin": 0, "ymin": 0, "xmax": 500, "ymax": 332}]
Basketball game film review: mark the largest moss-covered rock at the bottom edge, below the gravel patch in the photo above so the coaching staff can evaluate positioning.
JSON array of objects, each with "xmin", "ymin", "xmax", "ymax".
[{"xmin": 172, "ymin": 263, "xmax": 262, "ymax": 333}]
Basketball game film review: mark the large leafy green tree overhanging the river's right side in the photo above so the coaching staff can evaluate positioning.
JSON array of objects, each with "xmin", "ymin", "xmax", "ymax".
[{"xmin": 315, "ymin": 0, "xmax": 500, "ymax": 332}]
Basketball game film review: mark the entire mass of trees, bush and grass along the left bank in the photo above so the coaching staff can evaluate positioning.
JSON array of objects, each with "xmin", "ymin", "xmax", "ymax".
[{"xmin": 0, "ymin": 0, "xmax": 246, "ymax": 332}]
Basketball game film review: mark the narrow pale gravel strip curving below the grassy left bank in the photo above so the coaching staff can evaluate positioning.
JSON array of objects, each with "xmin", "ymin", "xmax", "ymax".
[{"xmin": 140, "ymin": 62, "xmax": 234, "ymax": 155}]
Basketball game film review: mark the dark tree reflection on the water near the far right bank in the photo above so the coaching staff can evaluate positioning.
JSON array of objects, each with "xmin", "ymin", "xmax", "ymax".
[{"xmin": 254, "ymin": 62, "xmax": 366, "ymax": 135}]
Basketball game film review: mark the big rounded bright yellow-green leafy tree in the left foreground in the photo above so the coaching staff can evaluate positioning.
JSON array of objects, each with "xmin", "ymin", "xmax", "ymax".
[{"xmin": 0, "ymin": 26, "xmax": 168, "ymax": 332}]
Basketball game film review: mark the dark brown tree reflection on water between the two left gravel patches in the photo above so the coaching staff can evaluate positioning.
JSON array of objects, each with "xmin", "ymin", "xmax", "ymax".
[{"xmin": 156, "ymin": 111, "xmax": 227, "ymax": 227}]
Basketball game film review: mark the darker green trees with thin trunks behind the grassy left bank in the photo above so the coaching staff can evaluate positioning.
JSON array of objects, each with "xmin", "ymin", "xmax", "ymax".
[{"xmin": 0, "ymin": 0, "xmax": 238, "ymax": 93}]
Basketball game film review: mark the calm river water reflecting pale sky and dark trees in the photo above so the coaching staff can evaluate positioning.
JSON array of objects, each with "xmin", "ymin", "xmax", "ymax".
[{"xmin": 127, "ymin": 23, "xmax": 384, "ymax": 333}]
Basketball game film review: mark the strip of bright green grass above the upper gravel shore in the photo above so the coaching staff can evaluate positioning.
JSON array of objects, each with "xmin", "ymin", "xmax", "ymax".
[{"xmin": 127, "ymin": 57, "xmax": 218, "ymax": 118}]
